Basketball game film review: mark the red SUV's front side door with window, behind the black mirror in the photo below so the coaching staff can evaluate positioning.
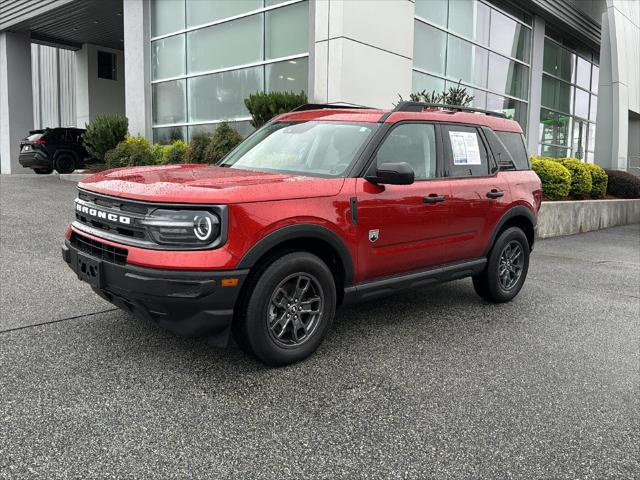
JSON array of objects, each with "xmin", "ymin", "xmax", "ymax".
[{"xmin": 356, "ymin": 122, "xmax": 450, "ymax": 281}]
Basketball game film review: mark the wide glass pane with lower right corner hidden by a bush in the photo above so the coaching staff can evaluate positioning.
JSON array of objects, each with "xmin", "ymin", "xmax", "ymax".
[{"xmin": 188, "ymin": 66, "xmax": 263, "ymax": 122}]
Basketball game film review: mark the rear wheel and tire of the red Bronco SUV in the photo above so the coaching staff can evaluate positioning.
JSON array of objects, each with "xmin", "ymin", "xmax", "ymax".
[{"xmin": 473, "ymin": 227, "xmax": 530, "ymax": 303}]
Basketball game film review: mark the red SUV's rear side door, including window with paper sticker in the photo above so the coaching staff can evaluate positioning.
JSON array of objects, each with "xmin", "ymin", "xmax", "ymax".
[{"xmin": 443, "ymin": 124, "xmax": 511, "ymax": 262}]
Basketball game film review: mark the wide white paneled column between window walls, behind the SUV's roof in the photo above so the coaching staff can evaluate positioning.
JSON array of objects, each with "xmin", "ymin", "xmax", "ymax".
[{"xmin": 309, "ymin": 0, "xmax": 414, "ymax": 108}]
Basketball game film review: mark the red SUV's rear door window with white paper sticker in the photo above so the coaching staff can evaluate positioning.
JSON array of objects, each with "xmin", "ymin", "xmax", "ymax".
[{"xmin": 444, "ymin": 126, "xmax": 489, "ymax": 177}]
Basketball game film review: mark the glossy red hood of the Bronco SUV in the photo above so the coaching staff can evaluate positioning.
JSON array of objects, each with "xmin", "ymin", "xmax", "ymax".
[{"xmin": 79, "ymin": 165, "xmax": 344, "ymax": 204}]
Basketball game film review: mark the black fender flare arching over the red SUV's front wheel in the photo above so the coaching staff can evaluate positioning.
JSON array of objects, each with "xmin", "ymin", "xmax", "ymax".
[{"xmin": 236, "ymin": 223, "xmax": 354, "ymax": 285}]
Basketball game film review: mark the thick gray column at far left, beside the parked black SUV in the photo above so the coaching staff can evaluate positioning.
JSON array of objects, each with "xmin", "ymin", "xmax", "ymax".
[{"xmin": 0, "ymin": 32, "xmax": 33, "ymax": 173}]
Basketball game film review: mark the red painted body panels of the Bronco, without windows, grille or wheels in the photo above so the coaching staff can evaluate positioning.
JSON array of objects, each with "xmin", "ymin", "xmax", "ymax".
[{"xmin": 67, "ymin": 110, "xmax": 540, "ymax": 283}]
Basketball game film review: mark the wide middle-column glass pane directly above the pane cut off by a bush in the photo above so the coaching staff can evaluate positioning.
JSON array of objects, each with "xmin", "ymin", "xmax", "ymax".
[{"xmin": 187, "ymin": 14, "xmax": 262, "ymax": 73}]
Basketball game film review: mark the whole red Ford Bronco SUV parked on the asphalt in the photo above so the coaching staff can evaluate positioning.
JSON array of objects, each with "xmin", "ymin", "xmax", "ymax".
[{"xmin": 63, "ymin": 102, "xmax": 541, "ymax": 365}]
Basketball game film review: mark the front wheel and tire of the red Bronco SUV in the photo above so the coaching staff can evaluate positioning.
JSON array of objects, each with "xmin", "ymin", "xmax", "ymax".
[{"xmin": 233, "ymin": 252, "xmax": 336, "ymax": 366}]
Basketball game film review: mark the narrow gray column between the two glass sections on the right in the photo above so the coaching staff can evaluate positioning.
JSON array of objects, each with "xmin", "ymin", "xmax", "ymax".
[{"xmin": 527, "ymin": 16, "xmax": 545, "ymax": 155}]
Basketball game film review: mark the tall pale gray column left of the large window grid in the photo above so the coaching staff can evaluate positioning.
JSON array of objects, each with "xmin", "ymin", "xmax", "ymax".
[{"xmin": 123, "ymin": 0, "xmax": 153, "ymax": 140}]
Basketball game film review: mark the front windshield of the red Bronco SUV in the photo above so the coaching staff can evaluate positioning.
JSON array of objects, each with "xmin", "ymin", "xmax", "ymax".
[{"xmin": 219, "ymin": 121, "xmax": 378, "ymax": 177}]
